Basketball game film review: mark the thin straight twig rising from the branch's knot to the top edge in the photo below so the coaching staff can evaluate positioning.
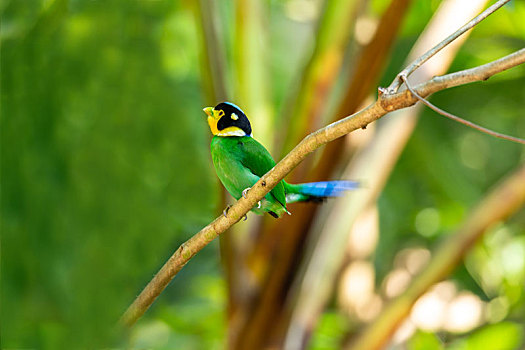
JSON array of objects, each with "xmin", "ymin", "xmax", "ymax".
[{"xmin": 388, "ymin": 0, "xmax": 510, "ymax": 93}]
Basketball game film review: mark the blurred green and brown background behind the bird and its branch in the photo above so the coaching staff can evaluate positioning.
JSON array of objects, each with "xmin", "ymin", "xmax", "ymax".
[{"xmin": 0, "ymin": 0, "xmax": 525, "ymax": 350}]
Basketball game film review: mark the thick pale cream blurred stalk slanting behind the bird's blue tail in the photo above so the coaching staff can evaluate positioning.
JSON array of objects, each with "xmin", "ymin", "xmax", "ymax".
[{"xmin": 286, "ymin": 0, "xmax": 492, "ymax": 349}]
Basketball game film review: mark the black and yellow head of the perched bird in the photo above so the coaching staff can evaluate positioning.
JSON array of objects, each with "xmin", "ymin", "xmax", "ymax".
[{"xmin": 203, "ymin": 102, "xmax": 252, "ymax": 136}]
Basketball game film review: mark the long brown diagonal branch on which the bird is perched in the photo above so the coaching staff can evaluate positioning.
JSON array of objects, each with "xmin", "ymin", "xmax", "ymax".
[{"xmin": 120, "ymin": 47, "xmax": 525, "ymax": 326}]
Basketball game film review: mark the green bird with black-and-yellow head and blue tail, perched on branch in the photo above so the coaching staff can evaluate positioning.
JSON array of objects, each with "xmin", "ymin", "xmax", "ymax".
[{"xmin": 203, "ymin": 102, "xmax": 358, "ymax": 218}]
